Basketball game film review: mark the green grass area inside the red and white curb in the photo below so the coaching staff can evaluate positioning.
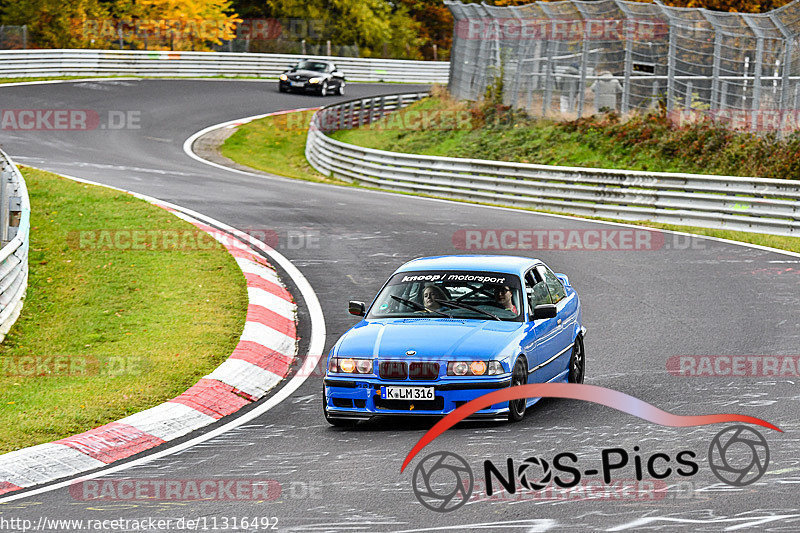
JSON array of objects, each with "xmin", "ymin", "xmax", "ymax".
[{"xmin": 0, "ymin": 169, "xmax": 247, "ymax": 452}]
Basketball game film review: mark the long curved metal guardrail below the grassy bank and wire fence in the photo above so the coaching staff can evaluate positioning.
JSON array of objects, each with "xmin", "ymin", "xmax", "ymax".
[{"xmin": 306, "ymin": 93, "xmax": 800, "ymax": 236}]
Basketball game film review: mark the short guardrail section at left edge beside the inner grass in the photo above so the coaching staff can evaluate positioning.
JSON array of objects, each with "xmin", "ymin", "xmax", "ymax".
[{"xmin": 0, "ymin": 150, "xmax": 31, "ymax": 341}]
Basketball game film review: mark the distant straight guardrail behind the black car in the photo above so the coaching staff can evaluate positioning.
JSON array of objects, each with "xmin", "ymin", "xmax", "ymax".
[{"xmin": 0, "ymin": 50, "xmax": 450, "ymax": 83}]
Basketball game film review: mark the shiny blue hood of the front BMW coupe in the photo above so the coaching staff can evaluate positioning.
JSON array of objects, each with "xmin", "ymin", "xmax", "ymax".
[{"xmin": 337, "ymin": 318, "xmax": 524, "ymax": 359}]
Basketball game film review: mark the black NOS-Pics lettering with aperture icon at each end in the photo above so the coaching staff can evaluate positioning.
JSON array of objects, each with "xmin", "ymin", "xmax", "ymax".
[{"xmin": 412, "ymin": 425, "xmax": 769, "ymax": 513}]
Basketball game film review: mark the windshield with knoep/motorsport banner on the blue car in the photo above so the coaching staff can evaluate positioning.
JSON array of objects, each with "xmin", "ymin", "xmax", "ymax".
[{"xmin": 367, "ymin": 270, "xmax": 522, "ymax": 322}]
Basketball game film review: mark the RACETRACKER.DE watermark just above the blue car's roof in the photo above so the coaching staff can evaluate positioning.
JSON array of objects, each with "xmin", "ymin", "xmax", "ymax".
[{"xmin": 452, "ymin": 228, "xmax": 705, "ymax": 251}]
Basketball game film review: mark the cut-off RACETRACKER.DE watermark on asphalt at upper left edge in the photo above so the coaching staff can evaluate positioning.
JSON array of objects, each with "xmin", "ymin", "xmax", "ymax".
[{"xmin": 0, "ymin": 109, "xmax": 142, "ymax": 131}]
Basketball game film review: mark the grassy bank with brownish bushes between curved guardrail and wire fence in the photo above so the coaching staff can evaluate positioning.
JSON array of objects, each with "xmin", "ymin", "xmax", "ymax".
[{"xmin": 332, "ymin": 90, "xmax": 800, "ymax": 179}]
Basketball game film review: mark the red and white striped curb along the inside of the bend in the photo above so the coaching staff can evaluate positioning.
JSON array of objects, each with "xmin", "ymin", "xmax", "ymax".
[{"xmin": 0, "ymin": 195, "xmax": 298, "ymax": 494}]
